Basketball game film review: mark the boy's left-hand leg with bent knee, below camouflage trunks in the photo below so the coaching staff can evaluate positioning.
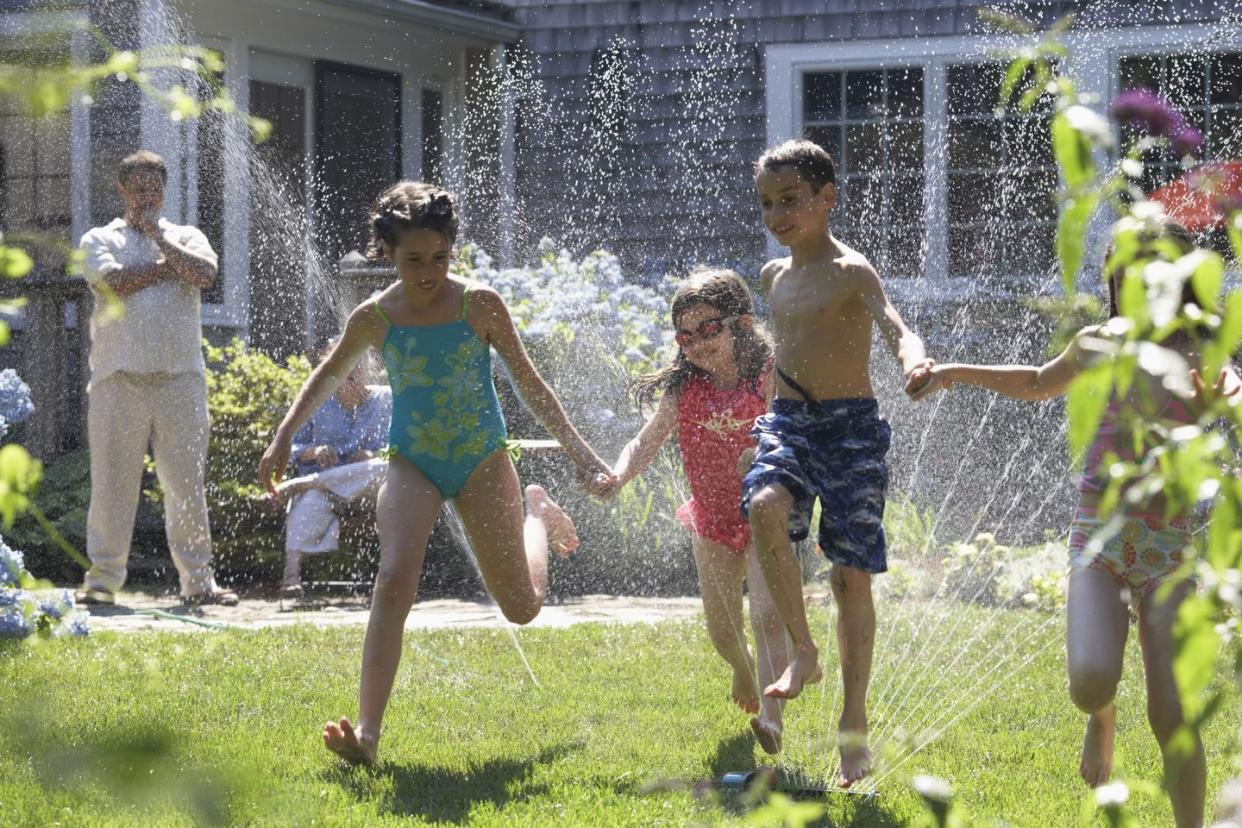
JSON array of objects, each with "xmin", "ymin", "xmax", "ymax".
[{"xmin": 750, "ymin": 483, "xmax": 822, "ymax": 699}]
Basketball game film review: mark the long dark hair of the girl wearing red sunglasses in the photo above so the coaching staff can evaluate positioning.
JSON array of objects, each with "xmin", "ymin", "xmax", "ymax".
[{"xmin": 630, "ymin": 269, "xmax": 773, "ymax": 408}]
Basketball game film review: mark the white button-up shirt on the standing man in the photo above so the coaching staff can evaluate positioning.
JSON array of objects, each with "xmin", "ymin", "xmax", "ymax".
[{"xmin": 79, "ymin": 218, "xmax": 216, "ymax": 382}]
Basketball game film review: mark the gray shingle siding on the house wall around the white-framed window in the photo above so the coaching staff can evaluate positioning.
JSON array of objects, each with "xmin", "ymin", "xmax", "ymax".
[{"xmin": 515, "ymin": 0, "xmax": 1227, "ymax": 269}]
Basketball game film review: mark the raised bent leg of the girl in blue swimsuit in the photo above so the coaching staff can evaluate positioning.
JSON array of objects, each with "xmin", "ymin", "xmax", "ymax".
[{"xmin": 455, "ymin": 449, "xmax": 578, "ymax": 624}]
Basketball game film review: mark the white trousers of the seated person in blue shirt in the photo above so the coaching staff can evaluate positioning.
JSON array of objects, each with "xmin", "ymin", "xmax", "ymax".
[{"xmin": 284, "ymin": 458, "xmax": 388, "ymax": 556}]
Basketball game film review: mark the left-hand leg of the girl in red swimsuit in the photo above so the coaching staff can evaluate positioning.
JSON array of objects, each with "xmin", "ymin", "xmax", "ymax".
[{"xmin": 693, "ymin": 535, "xmax": 759, "ymax": 714}]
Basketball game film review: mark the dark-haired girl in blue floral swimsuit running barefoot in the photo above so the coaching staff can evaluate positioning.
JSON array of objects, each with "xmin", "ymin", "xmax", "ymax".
[{"xmin": 258, "ymin": 181, "xmax": 611, "ymax": 762}]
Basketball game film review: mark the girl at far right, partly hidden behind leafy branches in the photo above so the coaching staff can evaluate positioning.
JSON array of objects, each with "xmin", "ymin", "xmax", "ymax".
[{"xmin": 928, "ymin": 222, "xmax": 1240, "ymax": 828}]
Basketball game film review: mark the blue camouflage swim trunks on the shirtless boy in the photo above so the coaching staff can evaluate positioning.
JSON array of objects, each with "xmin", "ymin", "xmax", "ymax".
[{"xmin": 741, "ymin": 398, "xmax": 892, "ymax": 574}]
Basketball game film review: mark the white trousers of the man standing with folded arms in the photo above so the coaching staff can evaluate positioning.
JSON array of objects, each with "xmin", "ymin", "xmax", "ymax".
[{"xmin": 86, "ymin": 372, "xmax": 216, "ymax": 595}]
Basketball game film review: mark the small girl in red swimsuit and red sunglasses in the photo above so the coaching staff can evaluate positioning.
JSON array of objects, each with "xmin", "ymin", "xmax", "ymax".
[{"xmin": 605, "ymin": 271, "xmax": 789, "ymax": 754}]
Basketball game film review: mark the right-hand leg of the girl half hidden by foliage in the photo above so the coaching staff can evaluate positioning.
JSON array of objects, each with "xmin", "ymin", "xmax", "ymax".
[{"xmin": 1139, "ymin": 582, "xmax": 1207, "ymax": 828}]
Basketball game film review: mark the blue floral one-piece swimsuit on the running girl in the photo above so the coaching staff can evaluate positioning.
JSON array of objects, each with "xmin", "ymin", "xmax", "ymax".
[{"xmin": 373, "ymin": 288, "xmax": 508, "ymax": 498}]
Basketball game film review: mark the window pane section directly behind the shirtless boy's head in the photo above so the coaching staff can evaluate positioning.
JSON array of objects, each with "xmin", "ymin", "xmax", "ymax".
[{"xmin": 802, "ymin": 67, "xmax": 924, "ymax": 277}]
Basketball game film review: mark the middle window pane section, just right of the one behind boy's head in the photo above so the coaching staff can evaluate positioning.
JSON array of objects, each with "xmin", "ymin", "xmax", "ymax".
[{"xmin": 945, "ymin": 63, "xmax": 1058, "ymax": 278}]
